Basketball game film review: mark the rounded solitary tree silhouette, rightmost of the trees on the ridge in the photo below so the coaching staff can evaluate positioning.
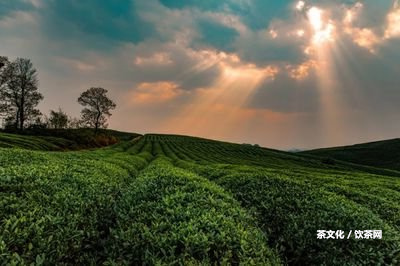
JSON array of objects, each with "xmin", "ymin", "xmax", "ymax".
[{"xmin": 78, "ymin": 88, "xmax": 116, "ymax": 133}]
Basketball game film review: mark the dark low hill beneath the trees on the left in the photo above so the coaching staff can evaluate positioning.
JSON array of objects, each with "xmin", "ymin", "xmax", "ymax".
[{"xmin": 0, "ymin": 128, "xmax": 139, "ymax": 151}]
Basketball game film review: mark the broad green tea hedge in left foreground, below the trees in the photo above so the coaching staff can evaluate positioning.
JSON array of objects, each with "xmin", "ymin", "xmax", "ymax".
[{"xmin": 0, "ymin": 147, "xmax": 147, "ymax": 265}]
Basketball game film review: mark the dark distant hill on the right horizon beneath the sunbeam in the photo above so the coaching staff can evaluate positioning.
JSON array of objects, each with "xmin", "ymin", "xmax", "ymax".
[{"xmin": 298, "ymin": 139, "xmax": 400, "ymax": 170}]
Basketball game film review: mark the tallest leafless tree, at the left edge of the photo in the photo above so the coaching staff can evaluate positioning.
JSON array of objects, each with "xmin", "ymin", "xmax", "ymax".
[{"xmin": 0, "ymin": 58, "xmax": 43, "ymax": 130}]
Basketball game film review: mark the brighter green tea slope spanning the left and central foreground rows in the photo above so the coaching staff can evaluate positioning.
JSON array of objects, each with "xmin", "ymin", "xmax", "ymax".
[{"xmin": 0, "ymin": 137, "xmax": 279, "ymax": 265}]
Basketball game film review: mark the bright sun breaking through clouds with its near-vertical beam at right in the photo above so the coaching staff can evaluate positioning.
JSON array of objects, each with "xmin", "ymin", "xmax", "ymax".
[{"xmin": 302, "ymin": 6, "xmax": 346, "ymax": 145}]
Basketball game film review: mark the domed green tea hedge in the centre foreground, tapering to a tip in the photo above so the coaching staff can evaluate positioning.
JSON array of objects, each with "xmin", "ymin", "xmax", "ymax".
[{"xmin": 109, "ymin": 157, "xmax": 278, "ymax": 265}]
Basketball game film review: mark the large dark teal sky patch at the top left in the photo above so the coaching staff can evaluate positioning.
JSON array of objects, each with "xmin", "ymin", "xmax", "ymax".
[{"xmin": 40, "ymin": 0, "xmax": 155, "ymax": 48}]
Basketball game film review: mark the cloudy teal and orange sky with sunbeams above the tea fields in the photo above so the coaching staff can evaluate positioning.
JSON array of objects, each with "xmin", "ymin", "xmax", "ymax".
[{"xmin": 0, "ymin": 0, "xmax": 400, "ymax": 149}]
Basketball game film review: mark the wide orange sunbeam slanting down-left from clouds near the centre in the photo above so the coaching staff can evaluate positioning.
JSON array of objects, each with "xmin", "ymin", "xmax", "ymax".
[{"xmin": 161, "ymin": 52, "xmax": 279, "ymax": 137}]
